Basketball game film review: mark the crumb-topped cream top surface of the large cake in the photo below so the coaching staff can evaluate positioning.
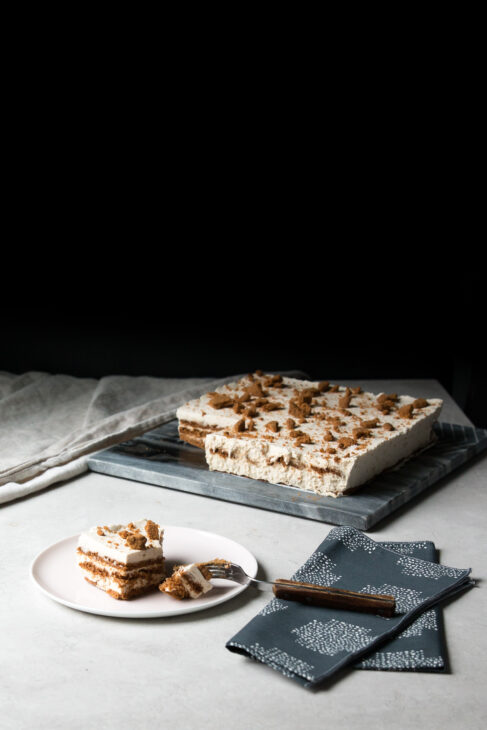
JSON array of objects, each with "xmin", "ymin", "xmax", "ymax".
[{"xmin": 176, "ymin": 374, "xmax": 443, "ymax": 460}]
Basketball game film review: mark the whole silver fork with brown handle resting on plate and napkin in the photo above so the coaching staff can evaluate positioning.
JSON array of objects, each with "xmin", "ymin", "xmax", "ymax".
[{"xmin": 203, "ymin": 560, "xmax": 395, "ymax": 617}]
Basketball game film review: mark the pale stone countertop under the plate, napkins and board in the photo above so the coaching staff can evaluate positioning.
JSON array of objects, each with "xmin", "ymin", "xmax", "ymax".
[{"xmin": 0, "ymin": 380, "xmax": 487, "ymax": 730}]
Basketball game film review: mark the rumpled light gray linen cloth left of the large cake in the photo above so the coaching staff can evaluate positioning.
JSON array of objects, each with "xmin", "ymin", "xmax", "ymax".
[{"xmin": 0, "ymin": 371, "xmax": 241, "ymax": 503}]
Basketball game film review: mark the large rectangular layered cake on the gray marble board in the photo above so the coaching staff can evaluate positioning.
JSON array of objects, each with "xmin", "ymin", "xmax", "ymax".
[{"xmin": 177, "ymin": 371, "xmax": 443, "ymax": 497}]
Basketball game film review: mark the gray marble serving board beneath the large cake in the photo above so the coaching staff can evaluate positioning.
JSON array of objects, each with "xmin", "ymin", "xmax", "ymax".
[{"xmin": 88, "ymin": 420, "xmax": 487, "ymax": 530}]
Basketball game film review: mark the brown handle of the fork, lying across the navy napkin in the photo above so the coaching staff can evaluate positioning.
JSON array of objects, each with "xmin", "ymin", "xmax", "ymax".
[{"xmin": 273, "ymin": 578, "xmax": 396, "ymax": 617}]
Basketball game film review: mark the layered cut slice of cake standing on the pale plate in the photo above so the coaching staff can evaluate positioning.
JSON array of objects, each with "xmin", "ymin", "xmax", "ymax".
[{"xmin": 77, "ymin": 520, "xmax": 165, "ymax": 600}]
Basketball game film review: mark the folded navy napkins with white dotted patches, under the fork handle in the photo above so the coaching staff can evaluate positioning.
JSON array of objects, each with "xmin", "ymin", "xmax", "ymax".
[{"xmin": 226, "ymin": 527, "xmax": 474, "ymax": 688}]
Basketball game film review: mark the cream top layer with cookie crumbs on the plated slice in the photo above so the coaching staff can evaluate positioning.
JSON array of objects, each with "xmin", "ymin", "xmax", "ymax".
[{"xmin": 78, "ymin": 519, "xmax": 164, "ymax": 566}]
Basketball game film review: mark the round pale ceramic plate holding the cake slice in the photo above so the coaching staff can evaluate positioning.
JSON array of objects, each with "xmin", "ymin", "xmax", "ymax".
[{"xmin": 30, "ymin": 526, "xmax": 257, "ymax": 618}]
